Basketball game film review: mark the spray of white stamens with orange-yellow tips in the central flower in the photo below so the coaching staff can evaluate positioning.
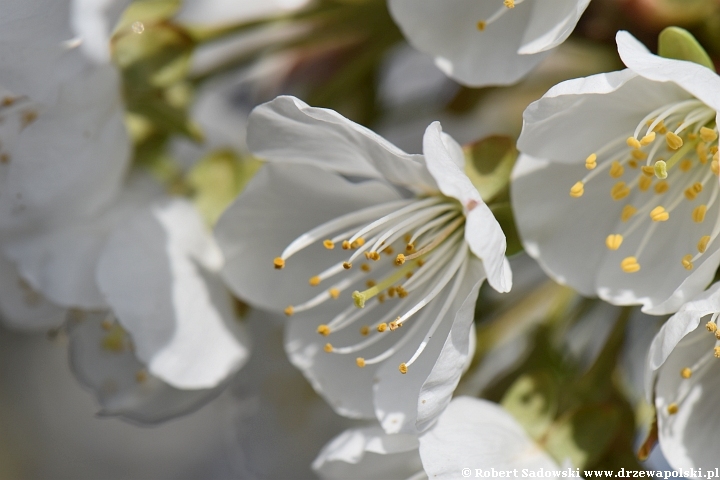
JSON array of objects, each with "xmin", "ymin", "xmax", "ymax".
[{"xmin": 273, "ymin": 195, "xmax": 469, "ymax": 373}]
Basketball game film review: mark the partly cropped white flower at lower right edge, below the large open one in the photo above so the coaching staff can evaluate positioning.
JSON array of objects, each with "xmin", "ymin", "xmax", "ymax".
[{"xmin": 646, "ymin": 283, "xmax": 720, "ymax": 469}]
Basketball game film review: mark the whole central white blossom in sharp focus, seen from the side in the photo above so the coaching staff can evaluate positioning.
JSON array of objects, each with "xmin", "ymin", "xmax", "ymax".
[{"xmin": 216, "ymin": 97, "xmax": 511, "ymax": 433}]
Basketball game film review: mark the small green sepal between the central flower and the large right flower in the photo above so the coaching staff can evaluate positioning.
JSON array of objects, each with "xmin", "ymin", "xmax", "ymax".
[{"xmin": 464, "ymin": 135, "xmax": 518, "ymax": 202}]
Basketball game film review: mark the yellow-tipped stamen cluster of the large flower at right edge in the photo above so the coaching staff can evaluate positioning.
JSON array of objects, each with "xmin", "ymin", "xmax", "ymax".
[{"xmin": 570, "ymin": 99, "xmax": 720, "ymax": 273}]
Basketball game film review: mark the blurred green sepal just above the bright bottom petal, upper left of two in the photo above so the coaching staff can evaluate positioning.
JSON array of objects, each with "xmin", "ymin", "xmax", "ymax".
[{"xmin": 501, "ymin": 371, "xmax": 559, "ymax": 440}]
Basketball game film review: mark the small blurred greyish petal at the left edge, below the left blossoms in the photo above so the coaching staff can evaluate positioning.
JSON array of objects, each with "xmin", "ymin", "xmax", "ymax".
[{"xmin": 0, "ymin": 255, "xmax": 67, "ymax": 330}]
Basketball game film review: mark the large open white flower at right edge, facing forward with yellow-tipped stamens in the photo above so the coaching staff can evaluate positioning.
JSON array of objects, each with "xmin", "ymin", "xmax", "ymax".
[{"xmin": 512, "ymin": 32, "xmax": 720, "ymax": 314}]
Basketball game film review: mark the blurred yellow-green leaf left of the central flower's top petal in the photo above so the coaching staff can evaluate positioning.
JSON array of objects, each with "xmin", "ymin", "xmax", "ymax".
[{"xmin": 187, "ymin": 150, "xmax": 261, "ymax": 225}]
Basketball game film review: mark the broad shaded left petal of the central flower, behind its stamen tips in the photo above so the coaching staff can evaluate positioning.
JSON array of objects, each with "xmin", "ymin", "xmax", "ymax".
[{"xmin": 215, "ymin": 164, "xmax": 400, "ymax": 312}]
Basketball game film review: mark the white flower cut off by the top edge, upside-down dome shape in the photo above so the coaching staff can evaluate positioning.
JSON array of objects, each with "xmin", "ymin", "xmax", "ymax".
[{"xmin": 388, "ymin": 0, "xmax": 590, "ymax": 86}]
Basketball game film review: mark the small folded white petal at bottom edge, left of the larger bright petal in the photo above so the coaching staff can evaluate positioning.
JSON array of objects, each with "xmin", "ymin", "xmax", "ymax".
[{"xmin": 313, "ymin": 426, "xmax": 422, "ymax": 480}]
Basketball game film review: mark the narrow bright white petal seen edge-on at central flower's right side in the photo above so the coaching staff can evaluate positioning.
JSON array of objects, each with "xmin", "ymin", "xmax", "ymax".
[{"xmin": 423, "ymin": 122, "xmax": 512, "ymax": 292}]
